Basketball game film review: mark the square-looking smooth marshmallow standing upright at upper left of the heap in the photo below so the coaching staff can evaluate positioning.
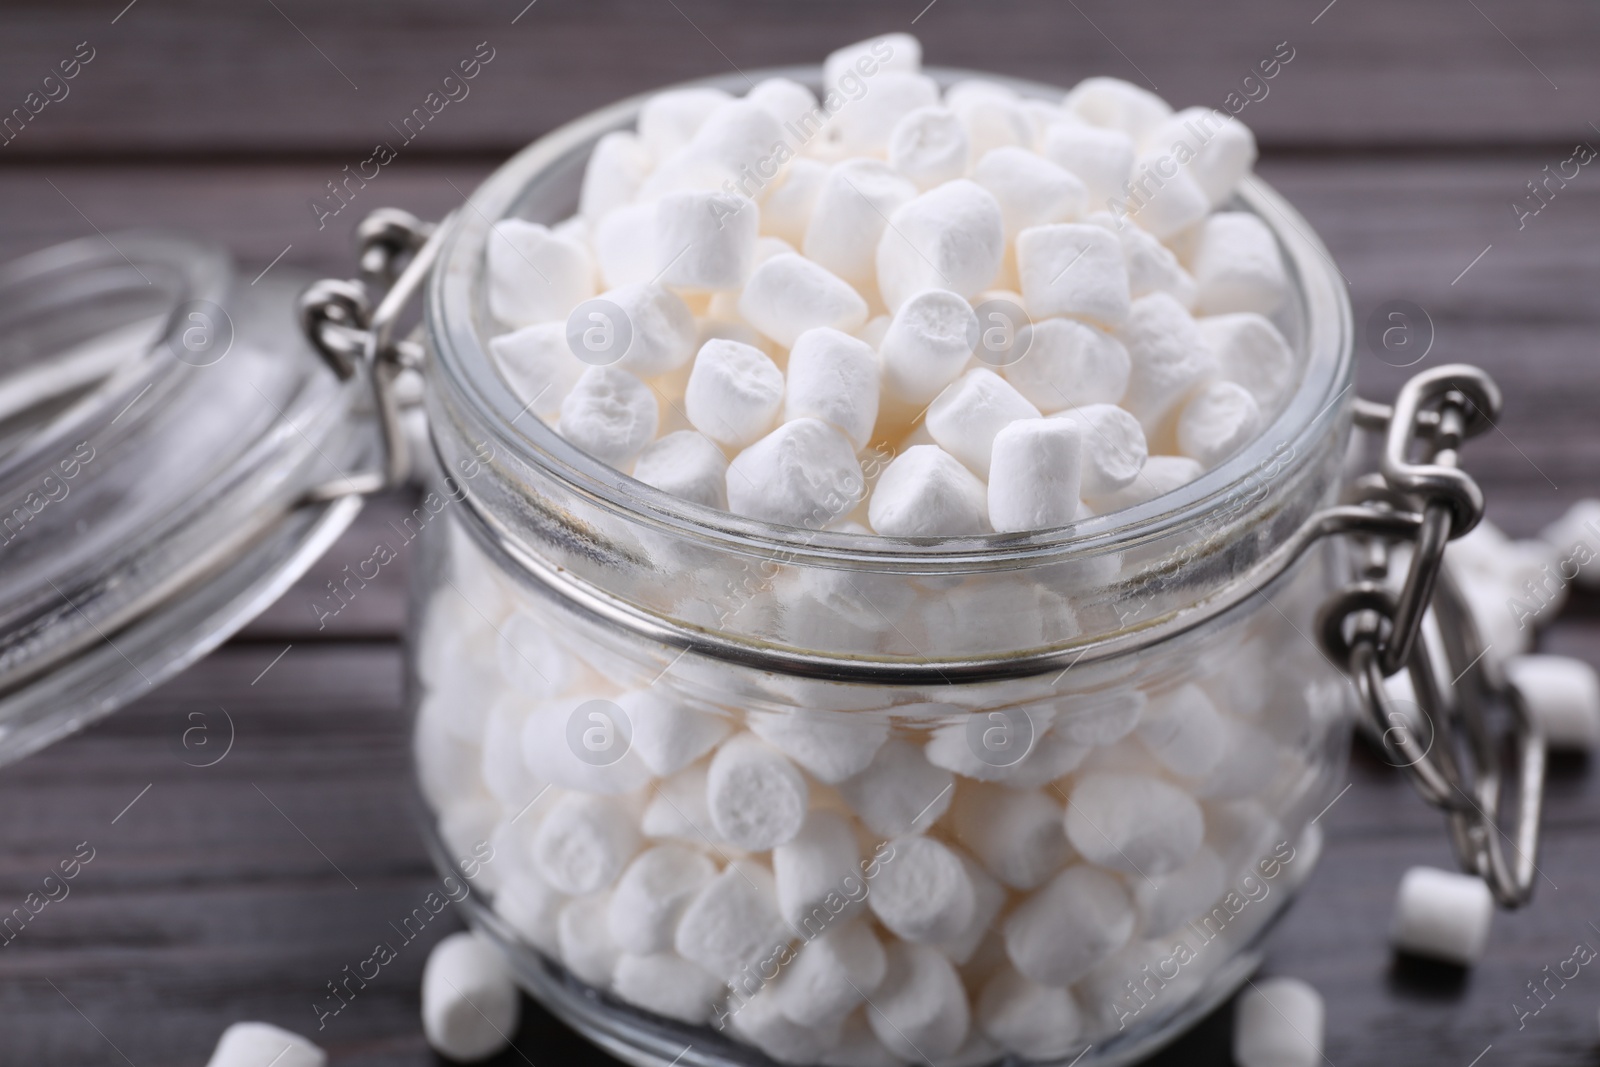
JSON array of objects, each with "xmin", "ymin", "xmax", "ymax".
[{"xmin": 656, "ymin": 189, "xmax": 770, "ymax": 290}]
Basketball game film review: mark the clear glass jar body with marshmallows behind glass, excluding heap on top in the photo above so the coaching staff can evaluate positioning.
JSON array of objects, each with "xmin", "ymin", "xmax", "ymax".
[{"xmin": 408, "ymin": 70, "xmax": 1354, "ymax": 1067}]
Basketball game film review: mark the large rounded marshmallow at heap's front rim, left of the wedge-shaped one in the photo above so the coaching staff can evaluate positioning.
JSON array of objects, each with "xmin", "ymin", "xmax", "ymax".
[{"xmin": 726, "ymin": 419, "xmax": 864, "ymax": 530}]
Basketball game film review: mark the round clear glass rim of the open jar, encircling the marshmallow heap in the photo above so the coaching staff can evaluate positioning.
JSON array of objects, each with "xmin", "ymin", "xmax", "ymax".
[{"xmin": 424, "ymin": 66, "xmax": 1355, "ymax": 573}]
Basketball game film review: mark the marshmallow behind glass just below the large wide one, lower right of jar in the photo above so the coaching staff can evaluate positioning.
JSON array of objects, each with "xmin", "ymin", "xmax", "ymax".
[{"xmin": 1003, "ymin": 864, "xmax": 1134, "ymax": 989}]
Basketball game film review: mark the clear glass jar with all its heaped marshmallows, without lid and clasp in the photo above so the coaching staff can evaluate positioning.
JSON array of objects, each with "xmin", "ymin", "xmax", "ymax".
[{"xmin": 406, "ymin": 34, "xmax": 1352, "ymax": 1065}]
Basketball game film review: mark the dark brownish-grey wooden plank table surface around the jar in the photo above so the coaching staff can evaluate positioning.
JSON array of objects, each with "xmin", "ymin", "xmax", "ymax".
[{"xmin": 0, "ymin": 0, "xmax": 1600, "ymax": 1067}]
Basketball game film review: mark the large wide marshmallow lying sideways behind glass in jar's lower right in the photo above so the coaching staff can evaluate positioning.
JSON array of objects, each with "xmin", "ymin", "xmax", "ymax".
[{"xmin": 1064, "ymin": 773, "xmax": 1205, "ymax": 878}]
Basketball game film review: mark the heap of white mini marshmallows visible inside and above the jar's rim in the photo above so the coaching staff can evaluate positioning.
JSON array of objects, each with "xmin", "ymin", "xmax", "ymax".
[{"xmin": 486, "ymin": 34, "xmax": 1299, "ymax": 536}]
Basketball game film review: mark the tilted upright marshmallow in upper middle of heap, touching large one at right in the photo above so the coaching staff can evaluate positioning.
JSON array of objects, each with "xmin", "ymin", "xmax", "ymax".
[{"xmin": 802, "ymin": 160, "xmax": 917, "ymax": 285}]
